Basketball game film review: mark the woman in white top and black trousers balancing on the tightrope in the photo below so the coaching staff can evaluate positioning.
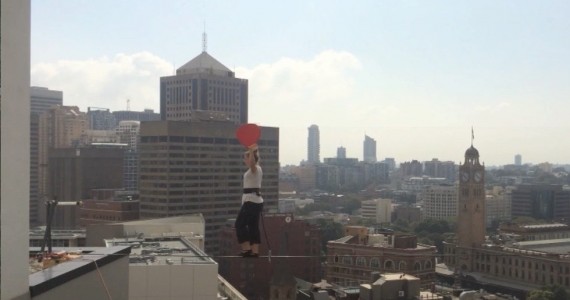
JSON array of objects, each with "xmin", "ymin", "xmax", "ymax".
[{"xmin": 235, "ymin": 144, "xmax": 263, "ymax": 257}]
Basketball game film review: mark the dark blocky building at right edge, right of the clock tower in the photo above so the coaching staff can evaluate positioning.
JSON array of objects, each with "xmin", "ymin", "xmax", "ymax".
[{"xmin": 511, "ymin": 184, "xmax": 570, "ymax": 221}]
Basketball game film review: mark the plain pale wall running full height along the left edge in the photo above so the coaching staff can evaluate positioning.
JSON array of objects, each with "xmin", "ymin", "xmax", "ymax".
[{"xmin": 0, "ymin": 0, "xmax": 31, "ymax": 300}]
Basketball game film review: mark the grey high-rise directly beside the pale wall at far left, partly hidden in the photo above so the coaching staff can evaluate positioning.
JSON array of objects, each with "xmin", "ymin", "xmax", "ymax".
[{"xmin": 30, "ymin": 86, "xmax": 63, "ymax": 226}]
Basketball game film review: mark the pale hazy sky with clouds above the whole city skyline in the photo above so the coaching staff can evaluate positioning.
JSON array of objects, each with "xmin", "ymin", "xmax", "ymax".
[{"xmin": 31, "ymin": 0, "xmax": 570, "ymax": 166}]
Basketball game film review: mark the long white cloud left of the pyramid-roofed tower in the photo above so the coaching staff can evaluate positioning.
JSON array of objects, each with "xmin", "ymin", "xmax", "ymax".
[{"xmin": 31, "ymin": 52, "xmax": 172, "ymax": 111}]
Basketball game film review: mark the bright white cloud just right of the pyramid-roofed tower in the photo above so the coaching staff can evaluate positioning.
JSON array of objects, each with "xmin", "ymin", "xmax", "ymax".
[{"xmin": 236, "ymin": 50, "xmax": 361, "ymax": 125}]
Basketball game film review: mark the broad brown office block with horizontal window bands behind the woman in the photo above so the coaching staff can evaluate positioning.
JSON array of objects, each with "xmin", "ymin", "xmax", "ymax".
[{"xmin": 139, "ymin": 121, "xmax": 279, "ymax": 254}]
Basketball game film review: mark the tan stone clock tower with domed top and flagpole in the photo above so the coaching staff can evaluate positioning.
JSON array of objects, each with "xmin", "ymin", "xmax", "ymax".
[{"xmin": 456, "ymin": 143, "xmax": 485, "ymax": 270}]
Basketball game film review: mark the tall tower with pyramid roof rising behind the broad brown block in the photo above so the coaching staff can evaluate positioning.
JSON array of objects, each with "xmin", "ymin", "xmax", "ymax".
[{"xmin": 160, "ymin": 51, "xmax": 248, "ymax": 124}]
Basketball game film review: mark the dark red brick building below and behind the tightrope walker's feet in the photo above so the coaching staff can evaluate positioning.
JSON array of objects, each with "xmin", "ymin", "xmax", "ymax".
[{"xmin": 216, "ymin": 214, "xmax": 322, "ymax": 300}]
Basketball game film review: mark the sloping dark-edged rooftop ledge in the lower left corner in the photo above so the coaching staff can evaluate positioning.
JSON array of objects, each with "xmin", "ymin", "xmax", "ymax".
[{"xmin": 29, "ymin": 246, "xmax": 131, "ymax": 297}]
